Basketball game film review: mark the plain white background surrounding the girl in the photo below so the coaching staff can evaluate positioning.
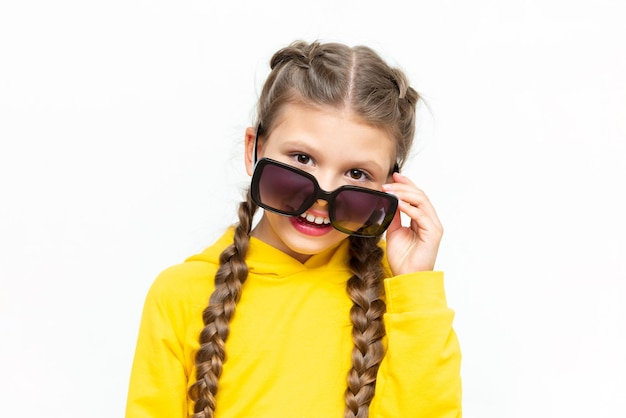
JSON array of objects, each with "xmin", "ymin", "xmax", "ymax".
[{"xmin": 0, "ymin": 0, "xmax": 626, "ymax": 418}]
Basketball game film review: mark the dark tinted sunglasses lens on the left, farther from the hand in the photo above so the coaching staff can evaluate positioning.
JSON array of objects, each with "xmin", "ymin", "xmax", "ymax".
[{"xmin": 259, "ymin": 164, "xmax": 315, "ymax": 215}]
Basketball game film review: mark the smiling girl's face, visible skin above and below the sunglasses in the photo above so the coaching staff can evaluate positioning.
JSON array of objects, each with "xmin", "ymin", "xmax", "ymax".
[{"xmin": 246, "ymin": 104, "xmax": 395, "ymax": 262}]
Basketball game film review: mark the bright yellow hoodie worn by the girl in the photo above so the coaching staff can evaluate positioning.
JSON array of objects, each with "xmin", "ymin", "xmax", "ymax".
[{"xmin": 126, "ymin": 229, "xmax": 461, "ymax": 418}]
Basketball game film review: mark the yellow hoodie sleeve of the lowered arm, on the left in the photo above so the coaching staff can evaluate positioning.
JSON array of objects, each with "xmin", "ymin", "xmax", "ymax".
[{"xmin": 126, "ymin": 269, "xmax": 193, "ymax": 418}]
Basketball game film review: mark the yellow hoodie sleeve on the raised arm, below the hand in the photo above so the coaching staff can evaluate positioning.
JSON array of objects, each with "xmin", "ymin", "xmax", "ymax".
[{"xmin": 370, "ymin": 272, "xmax": 462, "ymax": 418}]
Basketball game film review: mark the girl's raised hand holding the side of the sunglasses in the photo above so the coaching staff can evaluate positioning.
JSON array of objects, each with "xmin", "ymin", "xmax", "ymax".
[{"xmin": 383, "ymin": 173, "xmax": 443, "ymax": 276}]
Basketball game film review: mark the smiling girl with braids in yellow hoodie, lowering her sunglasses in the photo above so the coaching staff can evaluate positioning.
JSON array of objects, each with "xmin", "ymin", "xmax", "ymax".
[{"xmin": 126, "ymin": 42, "xmax": 461, "ymax": 418}]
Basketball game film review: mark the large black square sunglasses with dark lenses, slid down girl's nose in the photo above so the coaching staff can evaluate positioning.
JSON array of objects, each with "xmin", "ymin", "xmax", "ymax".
[{"xmin": 250, "ymin": 158, "xmax": 398, "ymax": 237}]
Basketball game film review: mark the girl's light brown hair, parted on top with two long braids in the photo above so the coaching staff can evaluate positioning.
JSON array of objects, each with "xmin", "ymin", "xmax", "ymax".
[{"xmin": 189, "ymin": 41, "xmax": 419, "ymax": 418}]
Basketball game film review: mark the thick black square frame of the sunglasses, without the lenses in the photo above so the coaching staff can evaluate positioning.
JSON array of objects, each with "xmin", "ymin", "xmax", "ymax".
[{"xmin": 250, "ymin": 158, "xmax": 398, "ymax": 237}]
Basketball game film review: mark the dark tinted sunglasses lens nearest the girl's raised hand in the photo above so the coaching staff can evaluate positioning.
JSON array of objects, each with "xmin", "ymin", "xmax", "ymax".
[{"xmin": 331, "ymin": 189, "xmax": 396, "ymax": 235}]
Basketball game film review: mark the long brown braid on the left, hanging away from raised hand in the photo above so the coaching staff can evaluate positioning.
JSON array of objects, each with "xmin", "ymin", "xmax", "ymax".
[{"xmin": 189, "ymin": 191, "xmax": 257, "ymax": 418}]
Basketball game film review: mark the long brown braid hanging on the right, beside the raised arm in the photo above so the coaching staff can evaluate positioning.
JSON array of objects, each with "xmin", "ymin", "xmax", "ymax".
[{"xmin": 345, "ymin": 237, "xmax": 386, "ymax": 418}]
